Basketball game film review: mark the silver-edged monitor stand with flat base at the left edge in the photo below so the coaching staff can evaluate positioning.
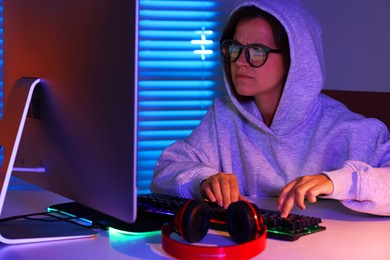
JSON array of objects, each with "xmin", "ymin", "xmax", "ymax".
[{"xmin": 0, "ymin": 78, "xmax": 97, "ymax": 244}]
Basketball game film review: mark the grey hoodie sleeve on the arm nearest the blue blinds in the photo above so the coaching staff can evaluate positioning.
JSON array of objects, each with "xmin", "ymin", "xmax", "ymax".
[{"xmin": 150, "ymin": 106, "xmax": 220, "ymax": 198}]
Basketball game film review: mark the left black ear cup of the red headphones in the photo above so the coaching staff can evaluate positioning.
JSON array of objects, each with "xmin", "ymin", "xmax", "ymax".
[{"xmin": 174, "ymin": 199, "xmax": 211, "ymax": 243}]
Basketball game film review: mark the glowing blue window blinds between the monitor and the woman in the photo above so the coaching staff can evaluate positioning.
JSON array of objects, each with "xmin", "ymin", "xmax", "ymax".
[{"xmin": 137, "ymin": 0, "xmax": 226, "ymax": 193}]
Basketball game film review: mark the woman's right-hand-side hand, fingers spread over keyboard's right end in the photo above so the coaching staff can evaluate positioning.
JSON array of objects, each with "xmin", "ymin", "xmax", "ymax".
[{"xmin": 277, "ymin": 174, "xmax": 333, "ymax": 217}]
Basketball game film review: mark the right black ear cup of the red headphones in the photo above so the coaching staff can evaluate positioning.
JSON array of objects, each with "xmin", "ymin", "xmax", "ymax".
[{"xmin": 226, "ymin": 200, "xmax": 263, "ymax": 244}]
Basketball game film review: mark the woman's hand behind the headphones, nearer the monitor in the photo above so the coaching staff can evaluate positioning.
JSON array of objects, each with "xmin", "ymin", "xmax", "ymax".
[{"xmin": 201, "ymin": 172, "xmax": 245, "ymax": 208}]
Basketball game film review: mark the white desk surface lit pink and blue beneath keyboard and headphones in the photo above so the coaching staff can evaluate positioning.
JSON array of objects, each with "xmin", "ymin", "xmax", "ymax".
[{"xmin": 0, "ymin": 182, "xmax": 390, "ymax": 260}]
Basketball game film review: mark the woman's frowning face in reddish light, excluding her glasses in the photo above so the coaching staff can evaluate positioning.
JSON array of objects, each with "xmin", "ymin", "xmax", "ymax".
[{"xmin": 231, "ymin": 18, "xmax": 286, "ymax": 104}]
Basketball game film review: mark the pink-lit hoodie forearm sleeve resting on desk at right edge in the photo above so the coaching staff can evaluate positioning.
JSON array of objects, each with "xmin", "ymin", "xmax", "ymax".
[{"xmin": 323, "ymin": 160, "xmax": 390, "ymax": 216}]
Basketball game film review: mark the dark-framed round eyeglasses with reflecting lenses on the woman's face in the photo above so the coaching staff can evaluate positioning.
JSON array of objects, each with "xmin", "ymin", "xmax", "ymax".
[{"xmin": 221, "ymin": 40, "xmax": 281, "ymax": 68}]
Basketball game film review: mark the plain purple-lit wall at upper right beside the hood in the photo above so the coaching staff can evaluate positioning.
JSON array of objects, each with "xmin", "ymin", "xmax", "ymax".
[{"xmin": 225, "ymin": 0, "xmax": 390, "ymax": 92}]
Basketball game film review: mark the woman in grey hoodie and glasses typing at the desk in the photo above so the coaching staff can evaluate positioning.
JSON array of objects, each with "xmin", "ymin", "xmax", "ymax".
[{"xmin": 151, "ymin": 0, "xmax": 390, "ymax": 217}]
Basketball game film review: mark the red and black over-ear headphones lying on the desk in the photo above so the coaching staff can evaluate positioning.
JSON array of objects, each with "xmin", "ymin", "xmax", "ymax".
[{"xmin": 162, "ymin": 199, "xmax": 267, "ymax": 260}]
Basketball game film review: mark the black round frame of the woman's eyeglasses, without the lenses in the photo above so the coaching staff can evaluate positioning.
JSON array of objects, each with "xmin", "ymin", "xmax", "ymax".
[{"xmin": 221, "ymin": 39, "xmax": 282, "ymax": 68}]
